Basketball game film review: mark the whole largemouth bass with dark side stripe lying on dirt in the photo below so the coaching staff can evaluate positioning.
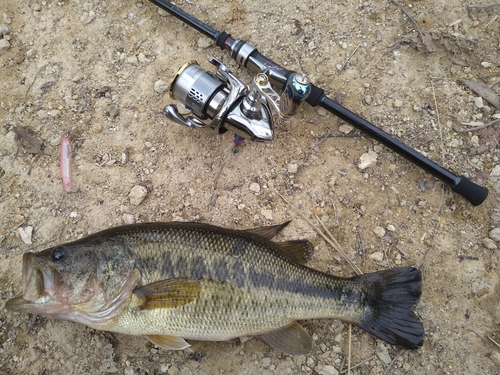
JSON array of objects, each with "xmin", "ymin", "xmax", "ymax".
[{"xmin": 5, "ymin": 222, "xmax": 424, "ymax": 355}]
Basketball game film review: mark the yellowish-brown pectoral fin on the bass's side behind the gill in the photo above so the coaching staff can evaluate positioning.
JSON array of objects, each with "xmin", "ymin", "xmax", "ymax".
[{"xmin": 134, "ymin": 277, "xmax": 201, "ymax": 310}]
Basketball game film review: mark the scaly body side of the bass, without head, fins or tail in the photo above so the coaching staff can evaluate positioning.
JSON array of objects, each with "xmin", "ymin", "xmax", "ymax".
[{"xmin": 113, "ymin": 224, "xmax": 363, "ymax": 340}]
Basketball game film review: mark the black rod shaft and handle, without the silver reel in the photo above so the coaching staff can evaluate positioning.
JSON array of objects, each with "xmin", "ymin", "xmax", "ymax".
[{"xmin": 146, "ymin": 0, "xmax": 488, "ymax": 206}]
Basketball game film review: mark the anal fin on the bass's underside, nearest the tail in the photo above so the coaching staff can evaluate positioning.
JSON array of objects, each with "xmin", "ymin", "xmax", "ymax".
[{"xmin": 257, "ymin": 322, "xmax": 312, "ymax": 355}]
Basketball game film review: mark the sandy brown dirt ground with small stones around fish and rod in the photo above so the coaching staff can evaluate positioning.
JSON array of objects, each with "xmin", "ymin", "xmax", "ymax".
[{"xmin": 0, "ymin": 0, "xmax": 500, "ymax": 375}]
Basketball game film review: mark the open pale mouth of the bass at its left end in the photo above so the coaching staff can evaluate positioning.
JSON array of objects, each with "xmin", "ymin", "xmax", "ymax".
[{"xmin": 5, "ymin": 252, "xmax": 59, "ymax": 313}]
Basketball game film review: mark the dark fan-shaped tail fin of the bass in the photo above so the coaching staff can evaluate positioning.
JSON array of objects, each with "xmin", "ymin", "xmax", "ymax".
[{"xmin": 353, "ymin": 267, "xmax": 424, "ymax": 349}]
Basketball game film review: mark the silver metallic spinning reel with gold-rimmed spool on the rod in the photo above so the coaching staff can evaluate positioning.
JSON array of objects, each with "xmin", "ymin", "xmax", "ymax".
[{"xmin": 163, "ymin": 57, "xmax": 311, "ymax": 141}]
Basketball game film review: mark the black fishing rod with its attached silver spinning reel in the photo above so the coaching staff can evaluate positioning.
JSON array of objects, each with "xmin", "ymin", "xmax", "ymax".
[{"xmin": 150, "ymin": 0, "xmax": 488, "ymax": 206}]
